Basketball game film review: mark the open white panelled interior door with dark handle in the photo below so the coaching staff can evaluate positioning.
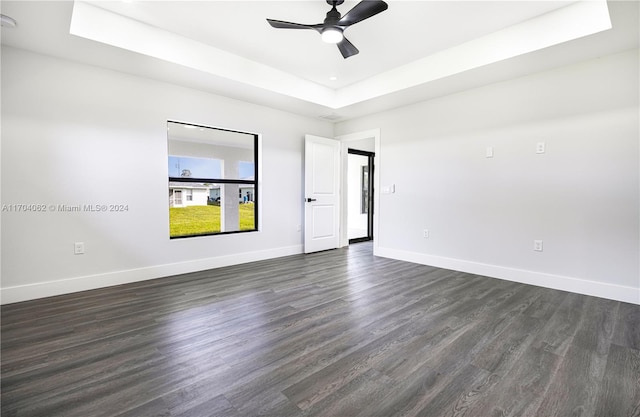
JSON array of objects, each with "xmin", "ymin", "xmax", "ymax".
[{"xmin": 304, "ymin": 135, "xmax": 341, "ymax": 253}]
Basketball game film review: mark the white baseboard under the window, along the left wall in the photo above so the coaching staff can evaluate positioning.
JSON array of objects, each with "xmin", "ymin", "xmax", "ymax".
[{"xmin": 0, "ymin": 245, "xmax": 303, "ymax": 304}]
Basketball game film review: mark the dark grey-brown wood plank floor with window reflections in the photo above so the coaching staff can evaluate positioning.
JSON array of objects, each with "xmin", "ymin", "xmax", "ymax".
[{"xmin": 1, "ymin": 243, "xmax": 640, "ymax": 417}]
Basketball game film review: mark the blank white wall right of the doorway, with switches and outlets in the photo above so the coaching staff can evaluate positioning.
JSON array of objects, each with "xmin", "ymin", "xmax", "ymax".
[{"xmin": 336, "ymin": 50, "xmax": 640, "ymax": 303}]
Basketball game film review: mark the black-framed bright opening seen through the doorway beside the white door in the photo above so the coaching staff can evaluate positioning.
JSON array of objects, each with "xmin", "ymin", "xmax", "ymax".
[{"xmin": 347, "ymin": 148, "xmax": 375, "ymax": 244}]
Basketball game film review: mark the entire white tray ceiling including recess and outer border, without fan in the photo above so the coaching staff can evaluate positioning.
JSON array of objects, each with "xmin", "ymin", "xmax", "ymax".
[{"xmin": 0, "ymin": 0, "xmax": 638, "ymax": 120}]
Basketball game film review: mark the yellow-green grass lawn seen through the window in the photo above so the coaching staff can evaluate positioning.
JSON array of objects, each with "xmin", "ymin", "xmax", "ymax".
[{"xmin": 169, "ymin": 204, "xmax": 255, "ymax": 237}]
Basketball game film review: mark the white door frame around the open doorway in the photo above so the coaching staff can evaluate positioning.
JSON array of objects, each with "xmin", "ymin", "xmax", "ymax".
[{"xmin": 336, "ymin": 129, "xmax": 381, "ymax": 250}]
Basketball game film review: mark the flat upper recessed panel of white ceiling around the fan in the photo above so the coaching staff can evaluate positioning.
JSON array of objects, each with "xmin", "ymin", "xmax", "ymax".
[{"xmin": 82, "ymin": 0, "xmax": 570, "ymax": 88}]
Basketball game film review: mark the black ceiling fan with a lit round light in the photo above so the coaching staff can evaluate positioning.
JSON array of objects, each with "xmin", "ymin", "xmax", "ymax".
[{"xmin": 267, "ymin": 0, "xmax": 389, "ymax": 59}]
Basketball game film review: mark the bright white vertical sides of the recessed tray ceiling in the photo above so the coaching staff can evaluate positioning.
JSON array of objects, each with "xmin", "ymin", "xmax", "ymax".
[{"xmin": 69, "ymin": 0, "xmax": 612, "ymax": 110}]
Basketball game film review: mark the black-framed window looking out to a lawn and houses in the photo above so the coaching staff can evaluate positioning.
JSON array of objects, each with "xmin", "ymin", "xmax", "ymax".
[{"xmin": 167, "ymin": 121, "xmax": 259, "ymax": 239}]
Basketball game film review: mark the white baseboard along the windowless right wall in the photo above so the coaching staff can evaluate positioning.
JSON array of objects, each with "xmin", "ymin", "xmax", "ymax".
[{"xmin": 374, "ymin": 246, "xmax": 640, "ymax": 305}]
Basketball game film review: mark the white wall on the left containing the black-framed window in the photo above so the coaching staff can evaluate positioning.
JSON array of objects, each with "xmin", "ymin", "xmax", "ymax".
[{"xmin": 1, "ymin": 47, "xmax": 333, "ymax": 303}]
